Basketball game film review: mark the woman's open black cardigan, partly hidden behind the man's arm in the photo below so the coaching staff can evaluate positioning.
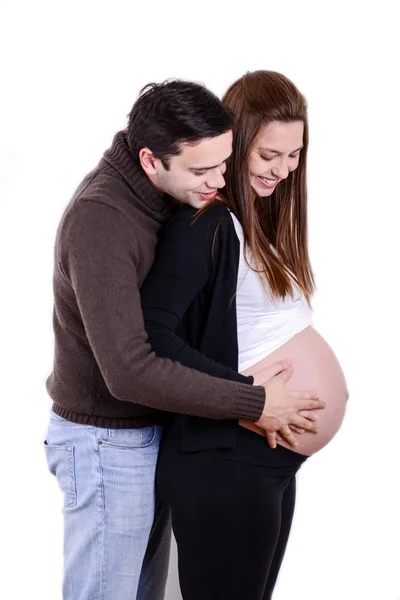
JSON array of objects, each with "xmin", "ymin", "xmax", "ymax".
[{"xmin": 141, "ymin": 205, "xmax": 253, "ymax": 451}]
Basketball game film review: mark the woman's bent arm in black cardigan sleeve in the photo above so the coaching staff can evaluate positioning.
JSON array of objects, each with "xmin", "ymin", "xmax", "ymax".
[{"xmin": 141, "ymin": 206, "xmax": 253, "ymax": 384}]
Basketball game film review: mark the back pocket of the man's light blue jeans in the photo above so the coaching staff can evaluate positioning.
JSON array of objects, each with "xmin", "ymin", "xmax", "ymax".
[{"xmin": 44, "ymin": 441, "xmax": 76, "ymax": 508}]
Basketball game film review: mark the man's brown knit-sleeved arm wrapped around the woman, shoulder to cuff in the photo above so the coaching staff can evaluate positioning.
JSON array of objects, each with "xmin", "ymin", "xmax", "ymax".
[{"xmin": 59, "ymin": 200, "xmax": 265, "ymax": 421}]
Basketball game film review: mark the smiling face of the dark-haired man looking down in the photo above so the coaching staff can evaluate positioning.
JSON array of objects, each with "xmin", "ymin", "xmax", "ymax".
[{"xmin": 152, "ymin": 131, "xmax": 232, "ymax": 208}]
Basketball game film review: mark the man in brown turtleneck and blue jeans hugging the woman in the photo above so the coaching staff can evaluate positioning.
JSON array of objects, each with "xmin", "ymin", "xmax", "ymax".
[{"xmin": 45, "ymin": 81, "xmax": 323, "ymax": 600}]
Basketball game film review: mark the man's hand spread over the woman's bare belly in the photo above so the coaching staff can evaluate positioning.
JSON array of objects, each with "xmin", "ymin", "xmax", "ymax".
[{"xmin": 256, "ymin": 359, "xmax": 325, "ymax": 448}]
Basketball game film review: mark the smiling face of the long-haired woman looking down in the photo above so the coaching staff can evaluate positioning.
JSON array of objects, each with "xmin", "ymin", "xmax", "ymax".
[{"xmin": 249, "ymin": 121, "xmax": 304, "ymax": 197}]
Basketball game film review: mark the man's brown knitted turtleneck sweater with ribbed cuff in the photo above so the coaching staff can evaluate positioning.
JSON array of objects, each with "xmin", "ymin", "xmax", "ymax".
[{"xmin": 47, "ymin": 132, "xmax": 265, "ymax": 428}]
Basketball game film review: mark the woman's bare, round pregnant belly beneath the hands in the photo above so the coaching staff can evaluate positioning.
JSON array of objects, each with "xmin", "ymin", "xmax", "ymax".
[{"xmin": 239, "ymin": 327, "xmax": 348, "ymax": 456}]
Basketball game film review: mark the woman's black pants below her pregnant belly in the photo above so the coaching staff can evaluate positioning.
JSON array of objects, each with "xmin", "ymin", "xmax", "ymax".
[{"xmin": 157, "ymin": 426, "xmax": 307, "ymax": 600}]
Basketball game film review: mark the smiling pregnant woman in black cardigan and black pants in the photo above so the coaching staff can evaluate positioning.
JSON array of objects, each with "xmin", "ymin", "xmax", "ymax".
[{"xmin": 143, "ymin": 71, "xmax": 348, "ymax": 600}]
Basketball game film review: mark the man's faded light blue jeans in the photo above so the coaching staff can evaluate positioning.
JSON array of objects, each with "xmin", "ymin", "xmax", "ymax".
[{"xmin": 45, "ymin": 411, "xmax": 171, "ymax": 600}]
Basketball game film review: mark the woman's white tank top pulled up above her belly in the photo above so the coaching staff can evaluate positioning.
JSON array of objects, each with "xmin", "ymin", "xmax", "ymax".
[{"xmin": 231, "ymin": 213, "xmax": 312, "ymax": 372}]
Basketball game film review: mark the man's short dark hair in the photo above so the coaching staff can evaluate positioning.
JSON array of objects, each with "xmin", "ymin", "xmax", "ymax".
[{"xmin": 126, "ymin": 80, "xmax": 233, "ymax": 169}]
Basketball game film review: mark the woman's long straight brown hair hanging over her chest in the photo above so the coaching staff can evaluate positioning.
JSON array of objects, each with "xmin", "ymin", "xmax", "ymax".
[{"xmin": 200, "ymin": 71, "xmax": 315, "ymax": 304}]
